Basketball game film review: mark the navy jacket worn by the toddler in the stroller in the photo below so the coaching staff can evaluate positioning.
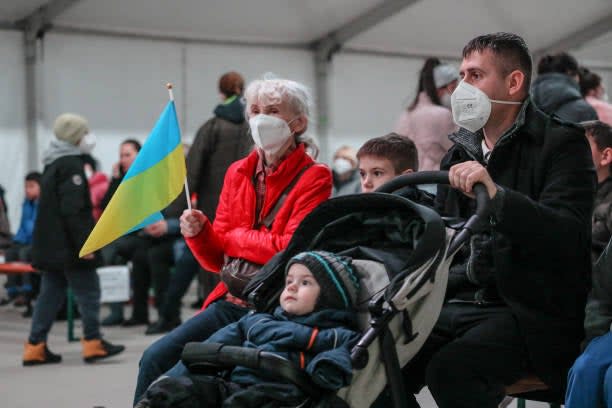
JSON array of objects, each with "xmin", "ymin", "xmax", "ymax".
[{"xmin": 207, "ymin": 306, "xmax": 359, "ymax": 390}]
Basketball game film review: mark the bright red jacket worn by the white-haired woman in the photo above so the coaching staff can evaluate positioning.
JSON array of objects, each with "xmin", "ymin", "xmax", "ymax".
[{"xmin": 186, "ymin": 144, "xmax": 332, "ymax": 308}]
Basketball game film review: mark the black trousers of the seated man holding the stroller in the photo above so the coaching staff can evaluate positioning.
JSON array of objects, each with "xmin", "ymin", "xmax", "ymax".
[{"xmin": 373, "ymin": 303, "xmax": 530, "ymax": 408}]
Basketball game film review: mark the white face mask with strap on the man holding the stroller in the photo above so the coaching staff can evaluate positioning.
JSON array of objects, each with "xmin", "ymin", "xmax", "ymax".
[{"xmin": 451, "ymin": 81, "xmax": 522, "ymax": 133}]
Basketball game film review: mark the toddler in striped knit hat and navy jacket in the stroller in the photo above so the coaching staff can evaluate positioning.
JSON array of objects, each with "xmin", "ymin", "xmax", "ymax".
[{"xmin": 136, "ymin": 251, "xmax": 359, "ymax": 408}]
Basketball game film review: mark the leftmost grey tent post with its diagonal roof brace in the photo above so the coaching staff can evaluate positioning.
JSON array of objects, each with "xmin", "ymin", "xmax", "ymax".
[{"xmin": 15, "ymin": 0, "xmax": 78, "ymax": 169}]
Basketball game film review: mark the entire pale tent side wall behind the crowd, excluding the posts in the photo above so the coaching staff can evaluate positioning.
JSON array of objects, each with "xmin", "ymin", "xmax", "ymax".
[{"xmin": 0, "ymin": 25, "xmax": 612, "ymax": 229}]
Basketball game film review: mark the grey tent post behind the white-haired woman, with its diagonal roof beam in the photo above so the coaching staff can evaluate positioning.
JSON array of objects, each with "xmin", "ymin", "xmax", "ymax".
[{"xmin": 311, "ymin": 0, "xmax": 419, "ymax": 160}]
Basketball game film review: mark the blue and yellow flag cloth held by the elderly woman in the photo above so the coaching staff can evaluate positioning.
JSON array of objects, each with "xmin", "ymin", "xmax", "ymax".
[{"xmin": 79, "ymin": 101, "xmax": 186, "ymax": 257}]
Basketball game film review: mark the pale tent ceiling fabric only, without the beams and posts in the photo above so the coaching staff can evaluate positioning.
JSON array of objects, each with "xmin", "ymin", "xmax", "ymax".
[{"xmin": 0, "ymin": 0, "xmax": 612, "ymax": 63}]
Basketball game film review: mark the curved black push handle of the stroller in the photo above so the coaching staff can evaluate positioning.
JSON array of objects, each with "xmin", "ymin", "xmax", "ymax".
[{"xmin": 376, "ymin": 171, "xmax": 491, "ymax": 253}]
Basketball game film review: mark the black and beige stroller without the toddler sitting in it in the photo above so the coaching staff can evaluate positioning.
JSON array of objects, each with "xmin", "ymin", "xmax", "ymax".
[{"xmin": 182, "ymin": 172, "xmax": 488, "ymax": 408}]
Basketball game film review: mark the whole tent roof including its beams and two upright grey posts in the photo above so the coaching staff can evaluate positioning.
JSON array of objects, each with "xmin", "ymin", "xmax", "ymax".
[{"xmin": 0, "ymin": 0, "xmax": 612, "ymax": 172}]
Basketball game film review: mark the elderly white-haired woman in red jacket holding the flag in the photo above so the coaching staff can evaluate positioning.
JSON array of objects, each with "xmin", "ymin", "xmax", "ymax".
[{"xmin": 134, "ymin": 79, "xmax": 332, "ymax": 402}]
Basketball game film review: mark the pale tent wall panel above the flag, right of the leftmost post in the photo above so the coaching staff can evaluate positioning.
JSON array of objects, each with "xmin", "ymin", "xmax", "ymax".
[{"xmin": 39, "ymin": 34, "xmax": 185, "ymax": 173}]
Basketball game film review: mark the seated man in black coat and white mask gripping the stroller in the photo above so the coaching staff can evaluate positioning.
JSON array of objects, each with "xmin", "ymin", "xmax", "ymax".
[{"xmin": 376, "ymin": 33, "xmax": 595, "ymax": 408}]
